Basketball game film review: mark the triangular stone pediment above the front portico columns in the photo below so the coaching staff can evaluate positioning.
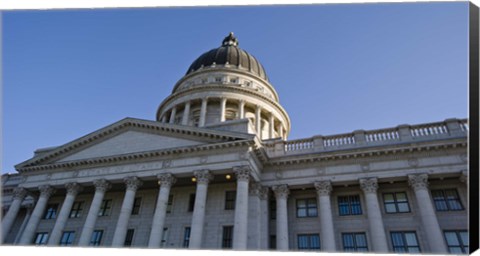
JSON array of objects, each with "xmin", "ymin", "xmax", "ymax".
[{"xmin": 15, "ymin": 118, "xmax": 253, "ymax": 171}]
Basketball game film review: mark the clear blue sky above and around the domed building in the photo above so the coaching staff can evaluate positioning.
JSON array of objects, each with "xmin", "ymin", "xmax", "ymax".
[{"xmin": 2, "ymin": 2, "xmax": 468, "ymax": 173}]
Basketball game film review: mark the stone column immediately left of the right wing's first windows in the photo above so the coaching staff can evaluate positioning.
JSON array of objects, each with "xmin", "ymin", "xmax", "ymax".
[{"xmin": 272, "ymin": 185, "xmax": 290, "ymax": 251}]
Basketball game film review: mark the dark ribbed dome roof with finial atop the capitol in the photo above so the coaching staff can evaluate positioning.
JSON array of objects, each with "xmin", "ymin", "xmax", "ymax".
[{"xmin": 186, "ymin": 33, "xmax": 268, "ymax": 80}]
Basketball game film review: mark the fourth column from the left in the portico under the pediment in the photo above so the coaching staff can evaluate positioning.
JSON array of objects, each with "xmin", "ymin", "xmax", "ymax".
[{"xmin": 78, "ymin": 179, "xmax": 111, "ymax": 246}]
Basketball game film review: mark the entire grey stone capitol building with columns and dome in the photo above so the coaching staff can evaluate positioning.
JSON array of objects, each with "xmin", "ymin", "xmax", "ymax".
[{"xmin": 1, "ymin": 33, "xmax": 469, "ymax": 254}]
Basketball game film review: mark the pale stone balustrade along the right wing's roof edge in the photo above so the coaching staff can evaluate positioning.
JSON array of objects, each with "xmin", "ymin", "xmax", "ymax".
[{"xmin": 270, "ymin": 119, "xmax": 469, "ymax": 156}]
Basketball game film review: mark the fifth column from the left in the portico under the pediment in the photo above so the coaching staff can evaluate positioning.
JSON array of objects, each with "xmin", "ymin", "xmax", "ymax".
[{"xmin": 112, "ymin": 177, "xmax": 142, "ymax": 247}]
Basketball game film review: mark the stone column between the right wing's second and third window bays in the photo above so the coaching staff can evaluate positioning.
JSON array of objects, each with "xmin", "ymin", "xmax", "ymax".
[{"xmin": 360, "ymin": 178, "xmax": 388, "ymax": 253}]
